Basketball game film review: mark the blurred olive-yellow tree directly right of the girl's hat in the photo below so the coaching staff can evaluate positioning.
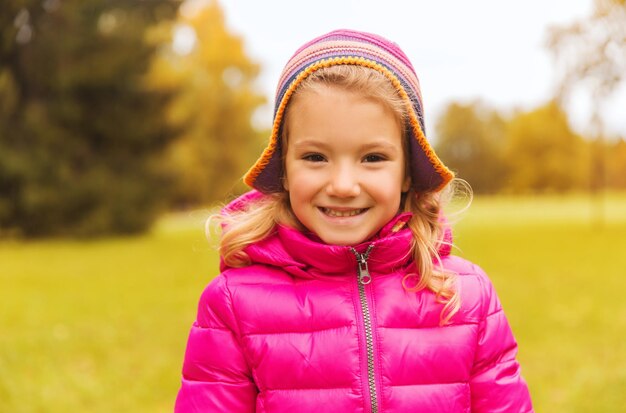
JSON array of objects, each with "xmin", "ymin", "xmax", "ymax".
[{"xmin": 435, "ymin": 102, "xmax": 506, "ymax": 193}]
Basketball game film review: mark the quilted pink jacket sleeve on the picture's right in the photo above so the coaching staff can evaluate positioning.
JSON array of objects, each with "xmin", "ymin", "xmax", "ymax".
[{"xmin": 470, "ymin": 270, "xmax": 533, "ymax": 413}]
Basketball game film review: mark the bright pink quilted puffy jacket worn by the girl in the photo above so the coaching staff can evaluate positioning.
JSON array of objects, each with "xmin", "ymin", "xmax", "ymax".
[{"xmin": 175, "ymin": 195, "xmax": 533, "ymax": 413}]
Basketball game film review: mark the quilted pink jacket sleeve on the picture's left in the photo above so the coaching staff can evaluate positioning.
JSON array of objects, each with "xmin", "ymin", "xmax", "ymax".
[{"xmin": 175, "ymin": 275, "xmax": 258, "ymax": 413}]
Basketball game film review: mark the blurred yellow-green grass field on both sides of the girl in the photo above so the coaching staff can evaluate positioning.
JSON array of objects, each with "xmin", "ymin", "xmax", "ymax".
[{"xmin": 0, "ymin": 195, "xmax": 626, "ymax": 413}]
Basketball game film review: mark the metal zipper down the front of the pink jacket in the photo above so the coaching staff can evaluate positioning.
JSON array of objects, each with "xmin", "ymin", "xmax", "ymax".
[{"xmin": 350, "ymin": 244, "xmax": 378, "ymax": 413}]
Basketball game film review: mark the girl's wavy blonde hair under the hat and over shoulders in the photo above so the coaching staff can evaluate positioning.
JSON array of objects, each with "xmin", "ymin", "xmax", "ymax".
[{"xmin": 211, "ymin": 65, "xmax": 460, "ymax": 325}]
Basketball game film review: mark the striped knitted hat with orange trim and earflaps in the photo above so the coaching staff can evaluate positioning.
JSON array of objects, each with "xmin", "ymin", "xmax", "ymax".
[{"xmin": 244, "ymin": 30, "xmax": 454, "ymax": 193}]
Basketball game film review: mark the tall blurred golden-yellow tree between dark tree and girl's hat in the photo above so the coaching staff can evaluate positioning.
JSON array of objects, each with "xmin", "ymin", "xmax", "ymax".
[{"xmin": 150, "ymin": 1, "xmax": 265, "ymax": 207}]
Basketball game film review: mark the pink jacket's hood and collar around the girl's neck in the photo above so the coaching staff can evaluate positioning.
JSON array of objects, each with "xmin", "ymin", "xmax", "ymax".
[{"xmin": 221, "ymin": 190, "xmax": 452, "ymax": 278}]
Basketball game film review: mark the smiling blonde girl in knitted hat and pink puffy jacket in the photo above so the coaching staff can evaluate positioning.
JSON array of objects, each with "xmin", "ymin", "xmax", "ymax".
[{"xmin": 176, "ymin": 30, "xmax": 532, "ymax": 413}]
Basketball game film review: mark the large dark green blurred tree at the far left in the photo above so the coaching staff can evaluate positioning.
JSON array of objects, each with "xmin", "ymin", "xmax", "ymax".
[{"xmin": 0, "ymin": 0, "xmax": 177, "ymax": 236}]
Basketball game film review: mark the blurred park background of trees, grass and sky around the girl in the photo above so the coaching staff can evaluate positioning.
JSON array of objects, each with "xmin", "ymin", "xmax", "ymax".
[{"xmin": 0, "ymin": 0, "xmax": 626, "ymax": 412}]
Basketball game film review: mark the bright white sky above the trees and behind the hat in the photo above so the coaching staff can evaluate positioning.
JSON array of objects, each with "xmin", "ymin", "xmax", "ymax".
[{"xmin": 211, "ymin": 0, "xmax": 626, "ymax": 135}]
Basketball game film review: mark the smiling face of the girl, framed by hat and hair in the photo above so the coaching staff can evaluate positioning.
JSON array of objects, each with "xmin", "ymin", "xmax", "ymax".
[{"xmin": 284, "ymin": 86, "xmax": 410, "ymax": 245}]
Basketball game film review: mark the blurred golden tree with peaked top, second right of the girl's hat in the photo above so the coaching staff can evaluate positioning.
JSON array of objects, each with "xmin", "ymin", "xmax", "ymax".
[{"xmin": 506, "ymin": 101, "xmax": 589, "ymax": 192}]
